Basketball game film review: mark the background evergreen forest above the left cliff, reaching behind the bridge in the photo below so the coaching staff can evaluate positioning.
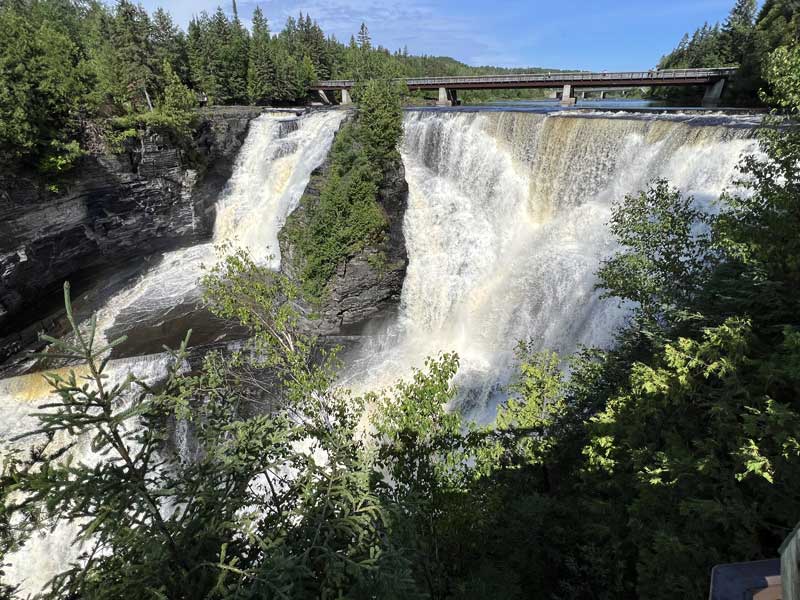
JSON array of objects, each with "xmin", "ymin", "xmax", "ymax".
[{"xmin": 0, "ymin": 0, "xmax": 560, "ymax": 175}]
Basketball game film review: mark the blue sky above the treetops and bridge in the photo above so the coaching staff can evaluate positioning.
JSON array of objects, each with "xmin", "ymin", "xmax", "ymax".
[{"xmin": 142, "ymin": 0, "xmax": 734, "ymax": 71}]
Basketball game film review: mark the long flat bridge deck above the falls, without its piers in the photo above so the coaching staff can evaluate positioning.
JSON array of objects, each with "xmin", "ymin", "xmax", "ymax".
[{"xmin": 311, "ymin": 68, "xmax": 737, "ymax": 91}]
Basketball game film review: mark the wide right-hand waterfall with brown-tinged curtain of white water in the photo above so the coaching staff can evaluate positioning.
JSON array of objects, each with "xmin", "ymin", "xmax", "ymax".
[{"xmin": 345, "ymin": 111, "xmax": 755, "ymax": 421}]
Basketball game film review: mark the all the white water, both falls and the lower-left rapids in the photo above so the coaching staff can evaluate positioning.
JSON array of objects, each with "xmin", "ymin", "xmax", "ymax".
[{"xmin": 0, "ymin": 107, "xmax": 757, "ymax": 593}]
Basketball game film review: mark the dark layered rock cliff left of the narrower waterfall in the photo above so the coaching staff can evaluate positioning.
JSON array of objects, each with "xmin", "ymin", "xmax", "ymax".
[{"xmin": 0, "ymin": 107, "xmax": 261, "ymax": 352}]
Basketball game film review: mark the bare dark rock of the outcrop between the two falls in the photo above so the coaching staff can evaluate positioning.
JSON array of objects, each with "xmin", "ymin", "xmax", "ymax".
[{"xmin": 279, "ymin": 126, "xmax": 408, "ymax": 336}]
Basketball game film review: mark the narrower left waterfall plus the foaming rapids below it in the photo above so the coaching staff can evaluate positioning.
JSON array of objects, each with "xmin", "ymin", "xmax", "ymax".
[{"xmin": 0, "ymin": 111, "xmax": 346, "ymax": 594}]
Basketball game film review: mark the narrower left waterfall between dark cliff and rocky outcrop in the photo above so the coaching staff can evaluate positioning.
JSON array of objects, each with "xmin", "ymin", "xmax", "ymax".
[{"xmin": 93, "ymin": 111, "xmax": 345, "ymax": 346}]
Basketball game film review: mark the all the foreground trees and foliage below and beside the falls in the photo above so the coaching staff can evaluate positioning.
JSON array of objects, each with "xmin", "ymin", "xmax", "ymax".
[{"xmin": 0, "ymin": 34, "xmax": 800, "ymax": 599}]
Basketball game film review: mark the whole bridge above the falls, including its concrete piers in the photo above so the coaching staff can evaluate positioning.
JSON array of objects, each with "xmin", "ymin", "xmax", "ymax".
[{"xmin": 311, "ymin": 67, "xmax": 737, "ymax": 106}]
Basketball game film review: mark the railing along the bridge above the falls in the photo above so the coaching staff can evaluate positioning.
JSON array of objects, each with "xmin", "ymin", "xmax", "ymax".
[{"xmin": 314, "ymin": 67, "xmax": 737, "ymax": 88}]
